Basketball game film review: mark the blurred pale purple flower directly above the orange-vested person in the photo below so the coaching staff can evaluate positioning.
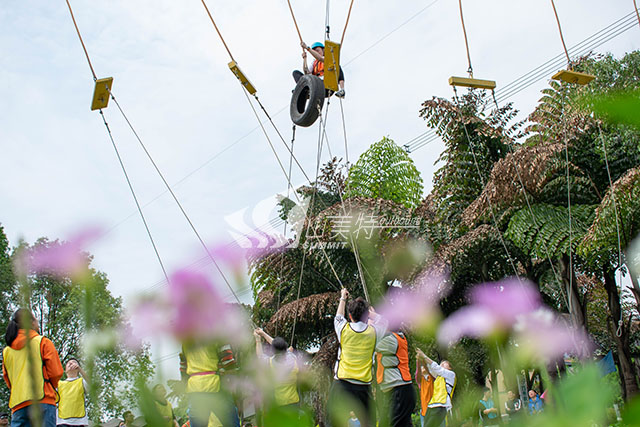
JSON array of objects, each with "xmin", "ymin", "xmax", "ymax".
[{"xmin": 377, "ymin": 274, "xmax": 448, "ymax": 329}]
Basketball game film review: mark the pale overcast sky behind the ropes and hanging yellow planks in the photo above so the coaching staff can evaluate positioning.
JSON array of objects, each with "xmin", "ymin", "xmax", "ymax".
[{"xmin": 0, "ymin": 0, "xmax": 640, "ymax": 375}]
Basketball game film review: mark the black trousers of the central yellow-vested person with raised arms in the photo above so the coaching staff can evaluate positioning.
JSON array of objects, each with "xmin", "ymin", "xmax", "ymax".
[{"xmin": 326, "ymin": 380, "xmax": 376, "ymax": 427}]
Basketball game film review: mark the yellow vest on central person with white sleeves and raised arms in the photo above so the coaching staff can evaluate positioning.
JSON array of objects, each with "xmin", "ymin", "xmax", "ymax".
[{"xmin": 337, "ymin": 324, "xmax": 376, "ymax": 383}]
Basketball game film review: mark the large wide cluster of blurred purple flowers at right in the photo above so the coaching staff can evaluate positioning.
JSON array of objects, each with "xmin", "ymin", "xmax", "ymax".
[{"xmin": 438, "ymin": 279, "xmax": 588, "ymax": 360}]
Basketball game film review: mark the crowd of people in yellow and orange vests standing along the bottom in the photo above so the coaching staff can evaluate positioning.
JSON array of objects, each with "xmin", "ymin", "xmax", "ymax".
[{"xmin": 0, "ymin": 300, "xmax": 544, "ymax": 427}]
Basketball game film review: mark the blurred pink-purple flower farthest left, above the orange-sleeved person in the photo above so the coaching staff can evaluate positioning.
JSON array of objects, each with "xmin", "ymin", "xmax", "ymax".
[{"xmin": 15, "ymin": 228, "xmax": 101, "ymax": 279}]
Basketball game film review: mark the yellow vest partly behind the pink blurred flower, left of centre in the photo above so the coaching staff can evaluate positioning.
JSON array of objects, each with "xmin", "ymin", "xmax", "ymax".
[{"xmin": 182, "ymin": 346, "xmax": 220, "ymax": 393}]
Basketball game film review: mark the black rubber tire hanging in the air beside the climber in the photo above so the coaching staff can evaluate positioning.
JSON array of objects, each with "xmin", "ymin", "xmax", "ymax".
[{"xmin": 289, "ymin": 74, "xmax": 324, "ymax": 127}]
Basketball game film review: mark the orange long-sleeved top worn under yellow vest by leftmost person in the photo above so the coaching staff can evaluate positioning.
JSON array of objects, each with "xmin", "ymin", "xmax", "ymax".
[{"xmin": 2, "ymin": 329, "xmax": 64, "ymax": 413}]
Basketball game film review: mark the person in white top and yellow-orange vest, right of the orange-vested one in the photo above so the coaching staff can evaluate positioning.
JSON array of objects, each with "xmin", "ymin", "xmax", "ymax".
[{"xmin": 416, "ymin": 349, "xmax": 457, "ymax": 427}]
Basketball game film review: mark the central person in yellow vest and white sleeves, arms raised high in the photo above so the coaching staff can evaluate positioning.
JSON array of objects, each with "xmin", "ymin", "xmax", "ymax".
[{"xmin": 327, "ymin": 289, "xmax": 387, "ymax": 427}]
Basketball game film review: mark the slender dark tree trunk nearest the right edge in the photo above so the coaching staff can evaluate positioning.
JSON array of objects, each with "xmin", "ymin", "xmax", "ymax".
[{"xmin": 603, "ymin": 269, "xmax": 638, "ymax": 400}]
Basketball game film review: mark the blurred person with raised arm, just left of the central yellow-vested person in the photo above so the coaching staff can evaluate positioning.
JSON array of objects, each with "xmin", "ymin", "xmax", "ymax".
[{"xmin": 253, "ymin": 328, "xmax": 300, "ymax": 409}]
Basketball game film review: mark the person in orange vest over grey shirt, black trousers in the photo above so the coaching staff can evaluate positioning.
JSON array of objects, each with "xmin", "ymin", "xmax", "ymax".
[{"xmin": 376, "ymin": 331, "xmax": 416, "ymax": 427}]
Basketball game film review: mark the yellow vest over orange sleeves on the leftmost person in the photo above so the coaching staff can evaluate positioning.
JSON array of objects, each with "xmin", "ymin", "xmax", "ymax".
[{"xmin": 2, "ymin": 335, "xmax": 44, "ymax": 408}]
